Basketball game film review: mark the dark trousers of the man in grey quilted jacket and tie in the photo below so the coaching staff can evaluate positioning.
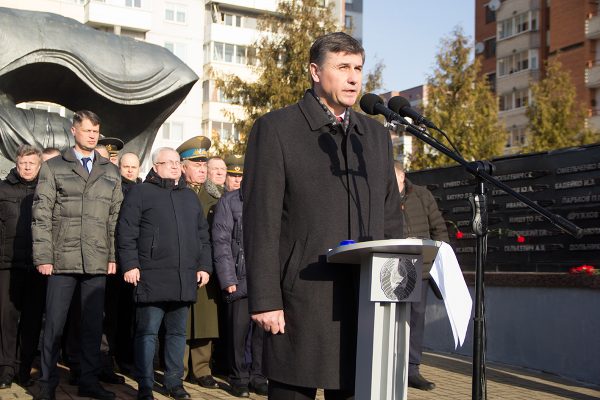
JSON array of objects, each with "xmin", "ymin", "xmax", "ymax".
[{"xmin": 39, "ymin": 274, "xmax": 106, "ymax": 389}]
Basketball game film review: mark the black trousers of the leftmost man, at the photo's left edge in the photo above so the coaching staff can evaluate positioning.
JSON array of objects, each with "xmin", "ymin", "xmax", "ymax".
[{"xmin": 0, "ymin": 266, "xmax": 46, "ymax": 378}]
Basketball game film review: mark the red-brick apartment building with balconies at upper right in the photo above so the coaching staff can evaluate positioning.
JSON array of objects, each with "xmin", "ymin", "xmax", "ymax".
[{"xmin": 475, "ymin": 0, "xmax": 600, "ymax": 153}]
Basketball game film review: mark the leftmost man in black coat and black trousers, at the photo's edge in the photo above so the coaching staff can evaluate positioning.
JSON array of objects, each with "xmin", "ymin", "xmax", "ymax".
[{"xmin": 0, "ymin": 144, "xmax": 46, "ymax": 389}]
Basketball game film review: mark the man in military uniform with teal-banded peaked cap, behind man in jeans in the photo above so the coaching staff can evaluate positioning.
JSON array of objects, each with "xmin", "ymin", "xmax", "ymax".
[{"xmin": 177, "ymin": 136, "xmax": 222, "ymax": 389}]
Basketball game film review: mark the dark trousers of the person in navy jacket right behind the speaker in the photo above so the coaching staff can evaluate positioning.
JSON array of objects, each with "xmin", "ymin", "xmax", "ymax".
[{"xmin": 227, "ymin": 298, "xmax": 267, "ymax": 386}]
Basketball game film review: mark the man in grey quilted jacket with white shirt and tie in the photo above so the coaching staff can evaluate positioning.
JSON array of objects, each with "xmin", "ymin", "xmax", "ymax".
[{"xmin": 32, "ymin": 111, "xmax": 123, "ymax": 400}]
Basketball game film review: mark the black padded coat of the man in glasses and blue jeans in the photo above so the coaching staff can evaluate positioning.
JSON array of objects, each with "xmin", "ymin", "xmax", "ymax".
[{"xmin": 116, "ymin": 170, "xmax": 212, "ymax": 303}]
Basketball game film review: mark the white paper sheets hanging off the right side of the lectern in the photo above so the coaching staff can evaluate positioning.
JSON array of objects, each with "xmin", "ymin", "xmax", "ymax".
[{"xmin": 431, "ymin": 242, "xmax": 473, "ymax": 349}]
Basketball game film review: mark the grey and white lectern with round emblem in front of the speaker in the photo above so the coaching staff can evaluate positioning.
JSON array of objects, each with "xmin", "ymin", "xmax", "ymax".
[{"xmin": 327, "ymin": 239, "xmax": 441, "ymax": 400}]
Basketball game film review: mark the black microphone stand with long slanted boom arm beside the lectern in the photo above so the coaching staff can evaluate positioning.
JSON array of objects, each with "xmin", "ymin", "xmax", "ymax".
[{"xmin": 386, "ymin": 120, "xmax": 583, "ymax": 400}]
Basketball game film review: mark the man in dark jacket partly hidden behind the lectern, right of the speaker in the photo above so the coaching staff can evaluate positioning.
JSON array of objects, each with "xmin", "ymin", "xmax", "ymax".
[{"xmin": 394, "ymin": 161, "xmax": 450, "ymax": 390}]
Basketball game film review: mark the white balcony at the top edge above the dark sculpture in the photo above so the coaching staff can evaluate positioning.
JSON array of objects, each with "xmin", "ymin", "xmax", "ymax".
[{"xmin": 83, "ymin": 0, "xmax": 152, "ymax": 32}]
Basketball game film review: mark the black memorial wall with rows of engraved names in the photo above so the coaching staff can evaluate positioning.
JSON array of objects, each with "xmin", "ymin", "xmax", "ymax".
[{"xmin": 408, "ymin": 145, "xmax": 600, "ymax": 272}]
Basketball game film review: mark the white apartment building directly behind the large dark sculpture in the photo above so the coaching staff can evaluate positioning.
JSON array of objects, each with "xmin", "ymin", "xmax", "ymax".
[{"xmin": 0, "ymin": 0, "xmax": 204, "ymax": 170}]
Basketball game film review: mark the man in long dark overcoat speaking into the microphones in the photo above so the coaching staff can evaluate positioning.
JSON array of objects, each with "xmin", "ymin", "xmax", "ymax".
[{"xmin": 242, "ymin": 32, "xmax": 402, "ymax": 400}]
